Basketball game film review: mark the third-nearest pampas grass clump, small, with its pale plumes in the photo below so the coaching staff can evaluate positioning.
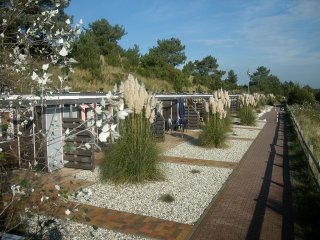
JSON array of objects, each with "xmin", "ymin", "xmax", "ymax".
[{"xmin": 238, "ymin": 94, "xmax": 257, "ymax": 126}]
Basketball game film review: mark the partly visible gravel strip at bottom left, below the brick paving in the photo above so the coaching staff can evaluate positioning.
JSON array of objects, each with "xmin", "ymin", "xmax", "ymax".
[{"xmin": 28, "ymin": 215, "xmax": 149, "ymax": 240}]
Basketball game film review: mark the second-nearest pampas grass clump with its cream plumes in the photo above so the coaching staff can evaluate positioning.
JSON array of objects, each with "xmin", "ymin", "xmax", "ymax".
[{"xmin": 198, "ymin": 90, "xmax": 231, "ymax": 147}]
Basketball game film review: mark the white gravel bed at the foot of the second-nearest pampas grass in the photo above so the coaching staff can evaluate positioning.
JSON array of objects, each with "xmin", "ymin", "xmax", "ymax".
[{"xmin": 164, "ymin": 140, "xmax": 253, "ymax": 162}]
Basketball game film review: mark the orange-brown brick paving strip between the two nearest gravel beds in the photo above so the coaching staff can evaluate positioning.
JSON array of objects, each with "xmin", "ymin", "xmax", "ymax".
[{"xmin": 43, "ymin": 201, "xmax": 192, "ymax": 240}]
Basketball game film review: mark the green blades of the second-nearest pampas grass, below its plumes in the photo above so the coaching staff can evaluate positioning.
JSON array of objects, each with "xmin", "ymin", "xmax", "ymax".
[{"xmin": 198, "ymin": 113, "xmax": 231, "ymax": 147}]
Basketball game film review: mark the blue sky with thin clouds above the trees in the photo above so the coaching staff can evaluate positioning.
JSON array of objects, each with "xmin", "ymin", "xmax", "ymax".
[{"xmin": 66, "ymin": 0, "xmax": 320, "ymax": 88}]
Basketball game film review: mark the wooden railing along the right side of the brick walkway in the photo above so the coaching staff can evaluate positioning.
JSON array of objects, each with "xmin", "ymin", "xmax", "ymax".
[{"xmin": 287, "ymin": 106, "xmax": 320, "ymax": 187}]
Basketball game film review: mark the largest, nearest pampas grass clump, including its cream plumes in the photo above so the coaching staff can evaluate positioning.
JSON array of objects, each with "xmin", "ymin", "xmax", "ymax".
[{"xmin": 100, "ymin": 75, "xmax": 164, "ymax": 184}]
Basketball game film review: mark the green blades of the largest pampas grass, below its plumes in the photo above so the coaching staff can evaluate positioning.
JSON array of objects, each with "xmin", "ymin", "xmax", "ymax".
[{"xmin": 100, "ymin": 114, "xmax": 164, "ymax": 184}]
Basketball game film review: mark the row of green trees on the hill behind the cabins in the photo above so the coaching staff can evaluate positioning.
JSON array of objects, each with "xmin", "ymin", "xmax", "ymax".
[{"xmin": 0, "ymin": 0, "xmax": 320, "ymax": 105}]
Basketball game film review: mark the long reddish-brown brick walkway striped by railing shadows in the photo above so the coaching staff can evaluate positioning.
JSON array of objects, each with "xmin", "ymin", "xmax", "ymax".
[{"xmin": 190, "ymin": 109, "xmax": 294, "ymax": 240}]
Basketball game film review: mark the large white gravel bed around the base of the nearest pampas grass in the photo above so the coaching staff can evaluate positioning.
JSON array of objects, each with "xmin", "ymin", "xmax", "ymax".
[{"xmin": 70, "ymin": 163, "xmax": 232, "ymax": 224}]
